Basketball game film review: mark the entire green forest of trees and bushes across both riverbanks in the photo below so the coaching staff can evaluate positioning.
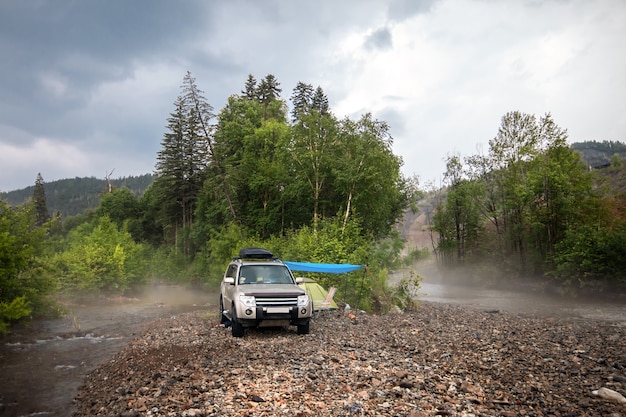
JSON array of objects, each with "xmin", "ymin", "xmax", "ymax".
[{"xmin": 0, "ymin": 72, "xmax": 626, "ymax": 332}]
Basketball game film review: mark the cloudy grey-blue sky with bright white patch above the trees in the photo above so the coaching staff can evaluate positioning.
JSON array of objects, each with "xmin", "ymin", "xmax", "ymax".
[{"xmin": 0, "ymin": 0, "xmax": 626, "ymax": 191}]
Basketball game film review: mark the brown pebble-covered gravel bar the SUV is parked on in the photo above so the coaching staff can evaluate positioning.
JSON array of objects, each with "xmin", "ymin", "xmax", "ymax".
[{"xmin": 70, "ymin": 302, "xmax": 626, "ymax": 417}]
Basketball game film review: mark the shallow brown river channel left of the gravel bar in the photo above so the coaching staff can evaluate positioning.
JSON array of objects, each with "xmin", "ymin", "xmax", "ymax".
[{"xmin": 0, "ymin": 285, "xmax": 218, "ymax": 417}]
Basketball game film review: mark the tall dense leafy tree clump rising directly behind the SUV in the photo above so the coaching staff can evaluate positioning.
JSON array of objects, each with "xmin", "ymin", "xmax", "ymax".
[{"xmin": 192, "ymin": 76, "xmax": 414, "ymax": 242}]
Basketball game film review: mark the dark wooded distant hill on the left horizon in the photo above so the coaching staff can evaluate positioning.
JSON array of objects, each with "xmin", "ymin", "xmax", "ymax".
[{"xmin": 0, "ymin": 174, "xmax": 153, "ymax": 218}]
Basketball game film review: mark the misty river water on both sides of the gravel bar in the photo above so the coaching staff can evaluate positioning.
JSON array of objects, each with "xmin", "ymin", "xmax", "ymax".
[{"xmin": 0, "ymin": 281, "xmax": 626, "ymax": 417}]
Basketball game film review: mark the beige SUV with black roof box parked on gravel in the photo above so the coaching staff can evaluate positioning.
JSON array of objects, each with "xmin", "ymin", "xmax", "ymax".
[{"xmin": 220, "ymin": 248, "xmax": 313, "ymax": 337}]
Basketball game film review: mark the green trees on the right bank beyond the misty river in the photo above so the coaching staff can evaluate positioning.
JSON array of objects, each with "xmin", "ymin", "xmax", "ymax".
[{"xmin": 433, "ymin": 112, "xmax": 624, "ymax": 287}]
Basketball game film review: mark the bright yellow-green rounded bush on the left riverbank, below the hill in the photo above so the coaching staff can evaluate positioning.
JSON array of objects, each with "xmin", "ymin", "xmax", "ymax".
[{"xmin": 53, "ymin": 216, "xmax": 145, "ymax": 293}]
